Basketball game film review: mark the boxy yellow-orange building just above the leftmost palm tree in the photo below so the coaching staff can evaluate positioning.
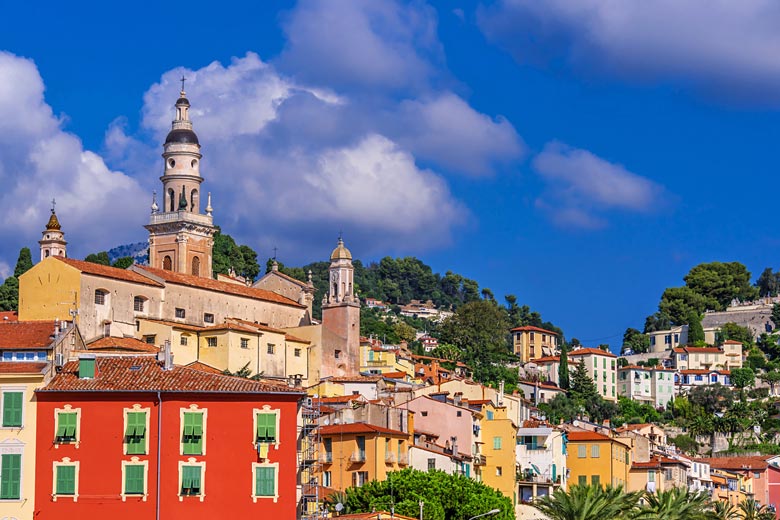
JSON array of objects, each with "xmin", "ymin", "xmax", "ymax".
[{"xmin": 566, "ymin": 431, "xmax": 631, "ymax": 487}]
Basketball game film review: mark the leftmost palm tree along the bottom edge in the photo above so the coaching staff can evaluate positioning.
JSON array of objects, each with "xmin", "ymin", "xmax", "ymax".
[{"xmin": 532, "ymin": 484, "xmax": 642, "ymax": 520}]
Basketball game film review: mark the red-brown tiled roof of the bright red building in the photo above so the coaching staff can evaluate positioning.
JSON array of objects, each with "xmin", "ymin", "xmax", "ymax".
[{"xmin": 38, "ymin": 356, "xmax": 302, "ymax": 394}]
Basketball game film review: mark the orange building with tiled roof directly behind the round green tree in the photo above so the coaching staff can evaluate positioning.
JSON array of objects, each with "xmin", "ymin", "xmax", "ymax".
[{"xmin": 319, "ymin": 423, "xmax": 413, "ymax": 491}]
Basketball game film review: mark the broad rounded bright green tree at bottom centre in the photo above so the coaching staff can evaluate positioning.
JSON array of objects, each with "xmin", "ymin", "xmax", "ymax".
[{"xmin": 344, "ymin": 468, "xmax": 515, "ymax": 520}]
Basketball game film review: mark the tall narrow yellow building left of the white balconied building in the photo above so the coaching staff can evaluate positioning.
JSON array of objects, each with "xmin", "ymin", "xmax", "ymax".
[{"xmin": 478, "ymin": 401, "xmax": 517, "ymax": 504}]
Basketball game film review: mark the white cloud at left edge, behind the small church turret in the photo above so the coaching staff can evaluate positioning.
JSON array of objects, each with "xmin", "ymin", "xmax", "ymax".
[{"xmin": 0, "ymin": 52, "xmax": 147, "ymax": 259}]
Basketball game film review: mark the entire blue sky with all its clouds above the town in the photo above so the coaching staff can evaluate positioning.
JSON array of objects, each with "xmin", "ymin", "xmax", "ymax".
[{"xmin": 0, "ymin": 0, "xmax": 780, "ymax": 345}]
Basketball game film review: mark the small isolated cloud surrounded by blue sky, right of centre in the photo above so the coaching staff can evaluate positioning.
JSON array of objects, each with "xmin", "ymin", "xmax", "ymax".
[{"xmin": 533, "ymin": 142, "xmax": 664, "ymax": 229}]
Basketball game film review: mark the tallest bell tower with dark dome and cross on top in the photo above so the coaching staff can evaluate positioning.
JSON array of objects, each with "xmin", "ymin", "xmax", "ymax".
[{"xmin": 144, "ymin": 78, "xmax": 216, "ymax": 278}]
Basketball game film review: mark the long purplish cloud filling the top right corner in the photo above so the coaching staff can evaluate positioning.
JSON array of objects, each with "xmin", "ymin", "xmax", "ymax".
[{"xmin": 477, "ymin": 0, "xmax": 780, "ymax": 104}]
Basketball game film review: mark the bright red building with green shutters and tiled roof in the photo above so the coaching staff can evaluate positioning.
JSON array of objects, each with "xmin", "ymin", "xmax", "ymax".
[{"xmin": 35, "ymin": 354, "xmax": 302, "ymax": 520}]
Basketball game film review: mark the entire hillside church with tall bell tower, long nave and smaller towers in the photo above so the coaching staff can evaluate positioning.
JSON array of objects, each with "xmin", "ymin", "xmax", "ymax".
[{"xmin": 19, "ymin": 90, "xmax": 360, "ymax": 382}]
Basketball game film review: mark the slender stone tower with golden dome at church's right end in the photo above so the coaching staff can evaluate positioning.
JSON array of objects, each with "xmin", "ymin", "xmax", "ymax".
[{"xmin": 320, "ymin": 237, "xmax": 360, "ymax": 377}]
